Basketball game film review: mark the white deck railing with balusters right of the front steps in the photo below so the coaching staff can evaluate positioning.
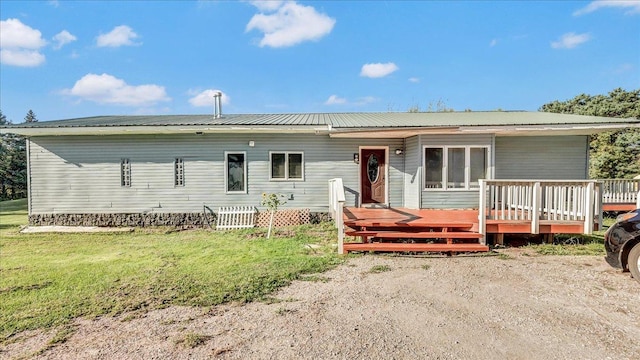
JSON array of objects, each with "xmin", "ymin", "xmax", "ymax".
[{"xmin": 478, "ymin": 180, "xmax": 602, "ymax": 242}]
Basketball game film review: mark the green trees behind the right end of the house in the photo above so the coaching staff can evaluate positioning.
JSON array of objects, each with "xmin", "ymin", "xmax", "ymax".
[{"xmin": 540, "ymin": 88, "xmax": 640, "ymax": 179}]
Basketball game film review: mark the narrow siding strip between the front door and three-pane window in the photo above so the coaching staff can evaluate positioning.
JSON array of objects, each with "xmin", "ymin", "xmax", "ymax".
[{"xmin": 404, "ymin": 136, "xmax": 422, "ymax": 209}]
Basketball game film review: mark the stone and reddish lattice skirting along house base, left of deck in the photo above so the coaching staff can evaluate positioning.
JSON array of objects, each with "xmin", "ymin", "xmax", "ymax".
[{"xmin": 29, "ymin": 209, "xmax": 329, "ymax": 228}]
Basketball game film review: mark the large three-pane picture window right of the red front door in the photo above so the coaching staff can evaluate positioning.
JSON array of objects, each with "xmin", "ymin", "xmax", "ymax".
[{"xmin": 424, "ymin": 146, "xmax": 489, "ymax": 190}]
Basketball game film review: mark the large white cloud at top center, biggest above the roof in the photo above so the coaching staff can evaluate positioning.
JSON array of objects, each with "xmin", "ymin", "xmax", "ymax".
[{"xmin": 245, "ymin": 1, "xmax": 336, "ymax": 48}]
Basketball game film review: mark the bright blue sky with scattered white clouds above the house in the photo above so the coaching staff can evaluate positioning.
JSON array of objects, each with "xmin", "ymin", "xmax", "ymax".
[{"xmin": 0, "ymin": 0, "xmax": 640, "ymax": 123}]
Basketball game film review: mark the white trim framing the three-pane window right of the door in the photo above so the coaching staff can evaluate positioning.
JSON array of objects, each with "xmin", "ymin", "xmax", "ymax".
[{"xmin": 421, "ymin": 145, "xmax": 492, "ymax": 191}]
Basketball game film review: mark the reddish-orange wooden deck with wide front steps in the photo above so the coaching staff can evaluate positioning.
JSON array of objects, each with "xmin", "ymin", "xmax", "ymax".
[{"xmin": 343, "ymin": 207, "xmax": 584, "ymax": 253}]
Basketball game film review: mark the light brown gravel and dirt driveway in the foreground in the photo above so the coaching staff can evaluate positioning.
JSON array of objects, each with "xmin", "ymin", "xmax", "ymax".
[{"xmin": 5, "ymin": 249, "xmax": 640, "ymax": 359}]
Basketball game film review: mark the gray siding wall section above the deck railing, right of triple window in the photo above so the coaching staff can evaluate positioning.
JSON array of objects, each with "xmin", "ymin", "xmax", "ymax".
[{"xmin": 496, "ymin": 136, "xmax": 589, "ymax": 180}]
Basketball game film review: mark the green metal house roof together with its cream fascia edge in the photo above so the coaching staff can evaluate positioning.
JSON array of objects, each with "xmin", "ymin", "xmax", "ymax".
[{"xmin": 0, "ymin": 111, "xmax": 640, "ymax": 136}]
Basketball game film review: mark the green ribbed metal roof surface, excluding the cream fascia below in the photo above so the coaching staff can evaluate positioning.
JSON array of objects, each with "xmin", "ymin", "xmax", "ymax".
[{"xmin": 9, "ymin": 111, "xmax": 640, "ymax": 128}]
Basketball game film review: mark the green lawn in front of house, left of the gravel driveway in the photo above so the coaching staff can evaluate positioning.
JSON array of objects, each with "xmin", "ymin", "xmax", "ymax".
[{"xmin": 0, "ymin": 201, "xmax": 342, "ymax": 343}]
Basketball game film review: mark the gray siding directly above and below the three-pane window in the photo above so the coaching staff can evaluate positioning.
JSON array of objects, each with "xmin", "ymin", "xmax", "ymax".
[{"xmin": 420, "ymin": 134, "xmax": 494, "ymax": 209}]
